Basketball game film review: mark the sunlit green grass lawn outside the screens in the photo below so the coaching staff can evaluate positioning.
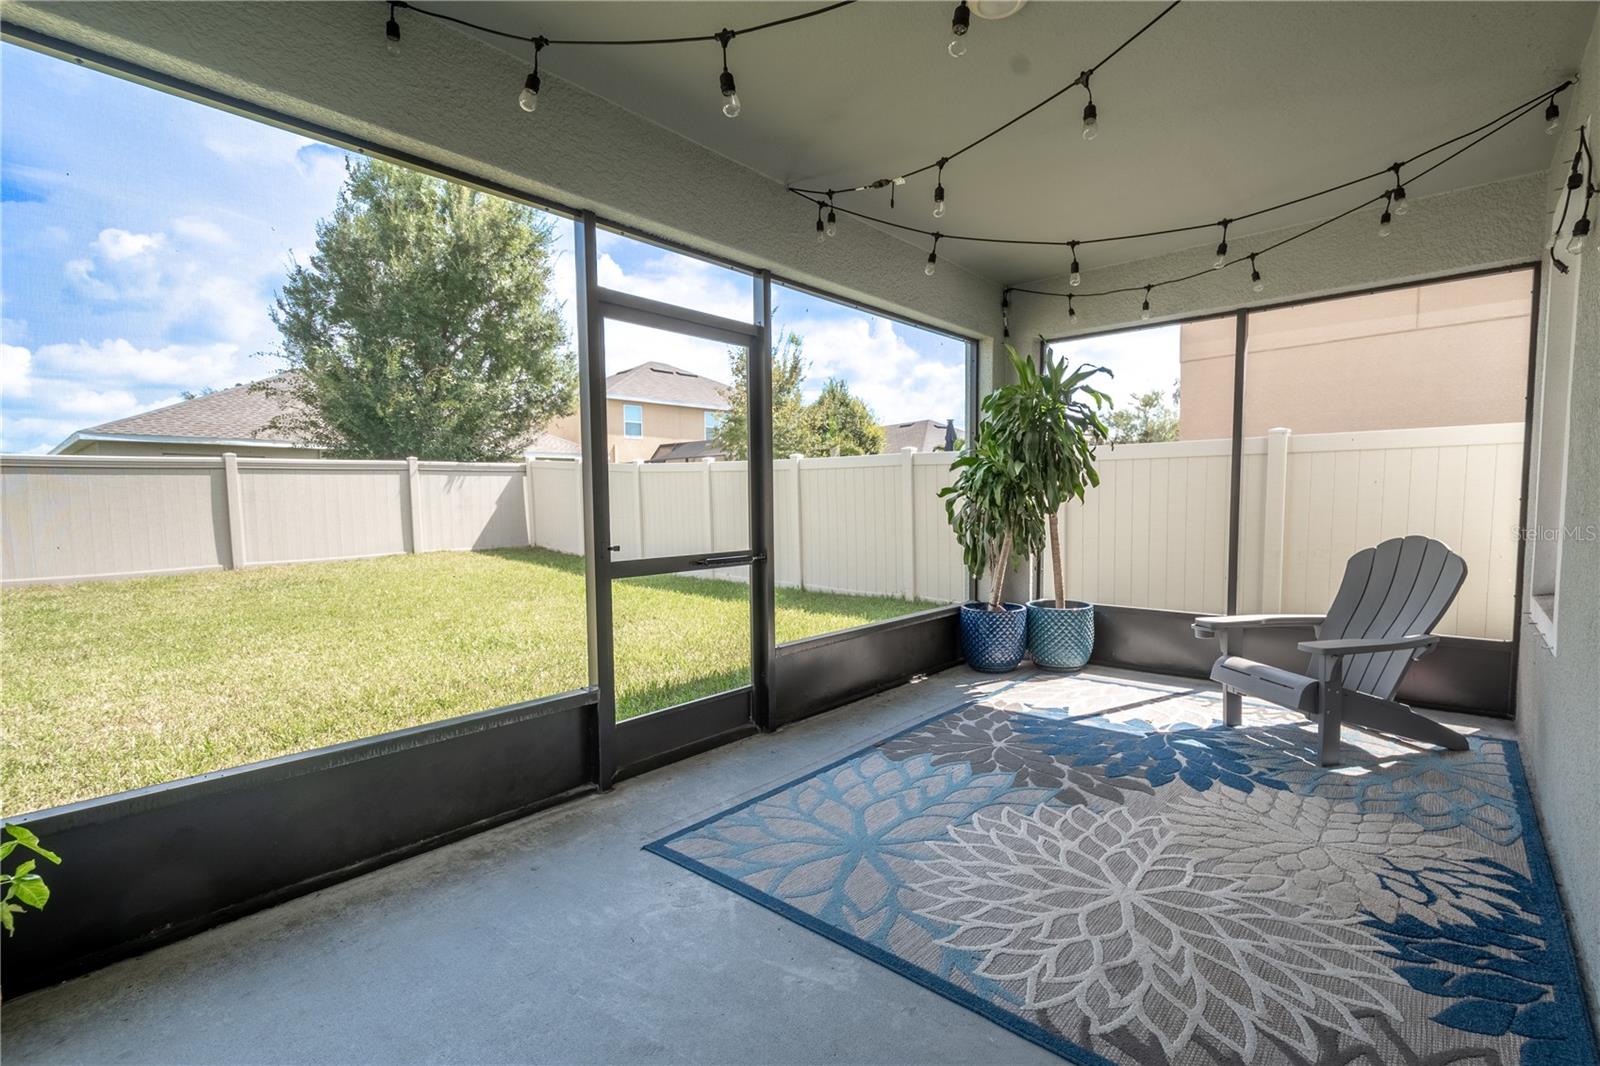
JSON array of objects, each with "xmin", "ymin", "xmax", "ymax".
[{"xmin": 0, "ymin": 549, "xmax": 933, "ymax": 813}]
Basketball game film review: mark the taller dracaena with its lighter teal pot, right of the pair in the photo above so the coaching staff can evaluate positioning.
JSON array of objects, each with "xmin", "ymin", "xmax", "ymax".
[{"xmin": 986, "ymin": 346, "xmax": 1110, "ymax": 671}]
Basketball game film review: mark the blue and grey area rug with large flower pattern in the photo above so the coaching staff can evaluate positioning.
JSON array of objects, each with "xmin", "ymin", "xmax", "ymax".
[{"xmin": 648, "ymin": 691, "xmax": 1597, "ymax": 1066}]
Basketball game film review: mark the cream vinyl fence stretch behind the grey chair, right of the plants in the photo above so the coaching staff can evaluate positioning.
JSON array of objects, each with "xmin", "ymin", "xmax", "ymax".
[{"xmin": 1043, "ymin": 423, "xmax": 1523, "ymax": 640}]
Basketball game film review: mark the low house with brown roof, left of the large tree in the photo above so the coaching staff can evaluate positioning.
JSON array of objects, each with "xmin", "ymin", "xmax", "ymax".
[{"xmin": 51, "ymin": 372, "xmax": 322, "ymax": 459}]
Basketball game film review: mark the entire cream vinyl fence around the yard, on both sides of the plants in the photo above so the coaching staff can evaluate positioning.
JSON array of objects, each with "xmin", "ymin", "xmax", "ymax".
[{"xmin": 0, "ymin": 423, "xmax": 1523, "ymax": 639}]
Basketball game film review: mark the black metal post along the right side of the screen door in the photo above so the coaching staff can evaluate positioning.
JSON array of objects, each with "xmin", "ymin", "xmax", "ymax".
[{"xmin": 744, "ymin": 271, "xmax": 778, "ymax": 731}]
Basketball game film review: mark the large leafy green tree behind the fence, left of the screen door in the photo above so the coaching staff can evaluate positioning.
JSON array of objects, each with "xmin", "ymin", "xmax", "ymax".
[{"xmin": 261, "ymin": 158, "xmax": 576, "ymax": 461}]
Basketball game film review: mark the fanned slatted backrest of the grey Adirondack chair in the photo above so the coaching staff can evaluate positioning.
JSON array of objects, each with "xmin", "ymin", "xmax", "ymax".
[{"xmin": 1318, "ymin": 536, "xmax": 1467, "ymax": 699}]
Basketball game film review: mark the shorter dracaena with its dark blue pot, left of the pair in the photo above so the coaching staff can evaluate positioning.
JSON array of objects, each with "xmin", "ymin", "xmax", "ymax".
[{"xmin": 939, "ymin": 394, "xmax": 1045, "ymax": 674}]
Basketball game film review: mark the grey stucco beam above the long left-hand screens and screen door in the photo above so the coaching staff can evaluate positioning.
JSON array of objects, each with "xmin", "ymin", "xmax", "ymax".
[{"xmin": 5, "ymin": 0, "xmax": 1000, "ymax": 390}]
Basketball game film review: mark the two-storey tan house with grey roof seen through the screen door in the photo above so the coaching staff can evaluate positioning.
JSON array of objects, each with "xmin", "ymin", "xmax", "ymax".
[{"xmin": 549, "ymin": 362, "xmax": 728, "ymax": 463}]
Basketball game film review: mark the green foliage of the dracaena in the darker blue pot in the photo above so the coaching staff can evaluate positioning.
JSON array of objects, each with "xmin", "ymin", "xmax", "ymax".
[{"xmin": 939, "ymin": 409, "xmax": 1045, "ymax": 610}]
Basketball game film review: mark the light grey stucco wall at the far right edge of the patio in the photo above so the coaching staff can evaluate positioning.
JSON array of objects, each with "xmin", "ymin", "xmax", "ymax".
[{"xmin": 1517, "ymin": 8, "xmax": 1600, "ymax": 1020}]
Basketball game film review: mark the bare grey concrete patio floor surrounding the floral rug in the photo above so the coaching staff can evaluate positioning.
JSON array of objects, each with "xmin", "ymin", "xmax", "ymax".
[{"xmin": 0, "ymin": 669, "xmax": 1507, "ymax": 1066}]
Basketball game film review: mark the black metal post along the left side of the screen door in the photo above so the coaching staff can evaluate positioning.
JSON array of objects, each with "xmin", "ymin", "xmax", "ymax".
[{"xmin": 573, "ymin": 211, "xmax": 616, "ymax": 791}]
